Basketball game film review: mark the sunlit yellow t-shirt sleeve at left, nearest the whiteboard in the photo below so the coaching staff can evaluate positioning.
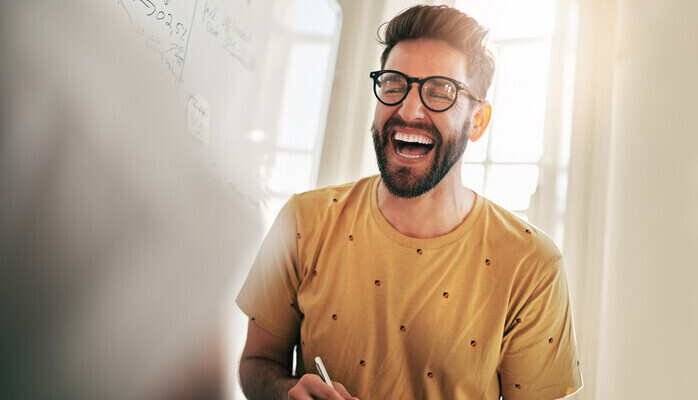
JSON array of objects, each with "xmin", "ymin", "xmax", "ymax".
[{"xmin": 236, "ymin": 196, "xmax": 301, "ymax": 340}]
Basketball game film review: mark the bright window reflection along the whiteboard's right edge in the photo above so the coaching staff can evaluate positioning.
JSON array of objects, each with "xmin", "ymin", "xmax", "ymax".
[{"xmin": 265, "ymin": 0, "xmax": 341, "ymax": 222}]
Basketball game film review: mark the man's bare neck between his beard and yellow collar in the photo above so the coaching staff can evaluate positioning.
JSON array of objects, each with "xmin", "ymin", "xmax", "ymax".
[{"xmin": 377, "ymin": 171, "xmax": 475, "ymax": 238}]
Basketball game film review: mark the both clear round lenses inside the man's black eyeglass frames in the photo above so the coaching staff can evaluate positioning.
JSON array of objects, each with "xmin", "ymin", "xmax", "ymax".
[{"xmin": 376, "ymin": 72, "xmax": 458, "ymax": 111}]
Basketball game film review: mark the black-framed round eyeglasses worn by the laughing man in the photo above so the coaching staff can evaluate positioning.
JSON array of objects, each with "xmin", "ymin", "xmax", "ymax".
[{"xmin": 369, "ymin": 69, "xmax": 482, "ymax": 112}]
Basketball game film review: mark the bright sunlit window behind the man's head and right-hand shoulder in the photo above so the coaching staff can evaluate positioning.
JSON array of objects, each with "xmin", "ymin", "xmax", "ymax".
[{"xmin": 455, "ymin": 0, "xmax": 576, "ymax": 247}]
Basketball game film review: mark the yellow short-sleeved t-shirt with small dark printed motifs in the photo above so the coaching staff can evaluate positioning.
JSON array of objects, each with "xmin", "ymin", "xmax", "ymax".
[{"xmin": 237, "ymin": 176, "xmax": 581, "ymax": 400}]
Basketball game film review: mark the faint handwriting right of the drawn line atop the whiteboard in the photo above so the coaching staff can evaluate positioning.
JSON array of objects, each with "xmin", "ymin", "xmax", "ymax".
[{"xmin": 201, "ymin": 0, "xmax": 257, "ymax": 72}]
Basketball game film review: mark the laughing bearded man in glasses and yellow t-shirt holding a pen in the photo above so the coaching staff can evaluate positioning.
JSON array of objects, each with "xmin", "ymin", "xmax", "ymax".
[{"xmin": 237, "ymin": 6, "xmax": 581, "ymax": 400}]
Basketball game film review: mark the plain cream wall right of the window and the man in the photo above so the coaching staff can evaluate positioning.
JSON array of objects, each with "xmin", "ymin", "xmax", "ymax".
[{"xmin": 565, "ymin": 0, "xmax": 698, "ymax": 400}]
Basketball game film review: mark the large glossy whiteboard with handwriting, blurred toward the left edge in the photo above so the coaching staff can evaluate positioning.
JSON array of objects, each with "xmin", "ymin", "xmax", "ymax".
[{"xmin": 0, "ymin": 0, "xmax": 341, "ymax": 400}]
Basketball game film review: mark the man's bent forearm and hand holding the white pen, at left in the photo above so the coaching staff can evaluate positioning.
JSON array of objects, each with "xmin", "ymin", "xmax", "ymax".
[{"xmin": 240, "ymin": 323, "xmax": 352, "ymax": 400}]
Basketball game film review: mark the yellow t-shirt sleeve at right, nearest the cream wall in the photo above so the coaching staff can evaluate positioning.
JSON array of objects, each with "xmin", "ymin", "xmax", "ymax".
[{"xmin": 499, "ymin": 257, "xmax": 582, "ymax": 400}]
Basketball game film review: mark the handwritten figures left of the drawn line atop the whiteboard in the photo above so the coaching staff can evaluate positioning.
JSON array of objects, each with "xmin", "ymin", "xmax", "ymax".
[{"xmin": 117, "ymin": 0, "xmax": 198, "ymax": 82}]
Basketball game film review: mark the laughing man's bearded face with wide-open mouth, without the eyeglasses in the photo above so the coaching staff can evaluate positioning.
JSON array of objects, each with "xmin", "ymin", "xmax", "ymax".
[{"xmin": 371, "ymin": 39, "xmax": 472, "ymax": 198}]
